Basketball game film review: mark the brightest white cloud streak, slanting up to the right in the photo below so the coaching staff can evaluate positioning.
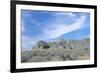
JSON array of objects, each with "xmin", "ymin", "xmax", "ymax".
[{"xmin": 43, "ymin": 16, "xmax": 85, "ymax": 39}]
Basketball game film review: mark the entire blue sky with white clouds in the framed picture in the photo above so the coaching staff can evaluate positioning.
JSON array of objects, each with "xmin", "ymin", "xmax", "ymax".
[{"xmin": 21, "ymin": 10, "xmax": 90, "ymax": 50}]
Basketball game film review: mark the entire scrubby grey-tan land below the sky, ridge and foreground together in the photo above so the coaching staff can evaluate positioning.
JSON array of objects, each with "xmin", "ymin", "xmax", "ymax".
[{"xmin": 21, "ymin": 39, "xmax": 90, "ymax": 63}]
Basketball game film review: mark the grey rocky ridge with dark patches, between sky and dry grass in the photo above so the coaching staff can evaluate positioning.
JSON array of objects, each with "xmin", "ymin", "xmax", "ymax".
[{"xmin": 33, "ymin": 38, "xmax": 90, "ymax": 49}]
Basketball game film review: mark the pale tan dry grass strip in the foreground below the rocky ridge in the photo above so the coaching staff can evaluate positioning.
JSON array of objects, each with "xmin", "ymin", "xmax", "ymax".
[{"xmin": 21, "ymin": 48, "xmax": 89, "ymax": 63}]
